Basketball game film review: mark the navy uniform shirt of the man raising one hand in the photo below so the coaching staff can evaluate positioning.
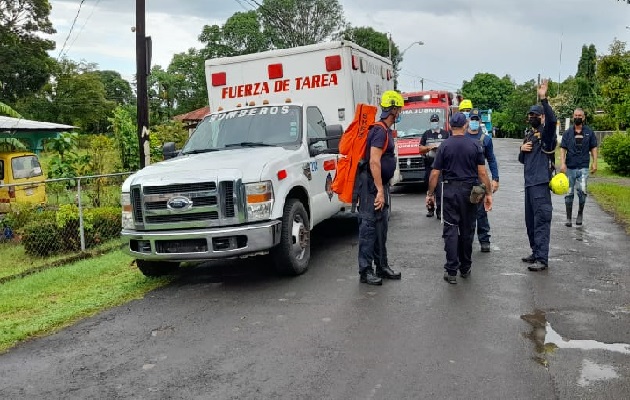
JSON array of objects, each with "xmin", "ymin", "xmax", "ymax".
[{"xmin": 518, "ymin": 99, "xmax": 557, "ymax": 187}]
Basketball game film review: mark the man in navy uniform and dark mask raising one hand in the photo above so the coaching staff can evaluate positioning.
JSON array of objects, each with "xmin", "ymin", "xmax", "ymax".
[{"xmin": 518, "ymin": 79, "xmax": 557, "ymax": 271}]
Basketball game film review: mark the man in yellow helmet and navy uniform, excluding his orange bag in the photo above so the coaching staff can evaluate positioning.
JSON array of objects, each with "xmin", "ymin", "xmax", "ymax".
[{"xmin": 357, "ymin": 90, "xmax": 404, "ymax": 285}]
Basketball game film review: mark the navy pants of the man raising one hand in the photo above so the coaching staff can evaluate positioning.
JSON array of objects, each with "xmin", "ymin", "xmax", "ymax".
[{"xmin": 525, "ymin": 183, "xmax": 553, "ymax": 264}]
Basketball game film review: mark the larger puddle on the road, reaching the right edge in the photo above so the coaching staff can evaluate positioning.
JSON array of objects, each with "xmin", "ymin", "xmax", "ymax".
[{"xmin": 521, "ymin": 310, "xmax": 630, "ymax": 368}]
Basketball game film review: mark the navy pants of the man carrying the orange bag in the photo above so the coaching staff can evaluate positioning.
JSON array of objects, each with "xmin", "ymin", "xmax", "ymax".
[{"xmin": 358, "ymin": 173, "xmax": 389, "ymax": 274}]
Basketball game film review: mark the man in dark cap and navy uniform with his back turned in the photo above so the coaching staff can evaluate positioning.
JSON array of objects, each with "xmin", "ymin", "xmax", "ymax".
[{"xmin": 426, "ymin": 112, "xmax": 492, "ymax": 284}]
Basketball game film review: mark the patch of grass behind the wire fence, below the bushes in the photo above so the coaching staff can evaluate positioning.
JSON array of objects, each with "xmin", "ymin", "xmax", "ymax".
[{"xmin": 0, "ymin": 239, "xmax": 123, "ymax": 283}]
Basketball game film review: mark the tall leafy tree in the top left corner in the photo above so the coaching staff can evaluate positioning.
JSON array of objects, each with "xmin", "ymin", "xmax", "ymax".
[{"xmin": 0, "ymin": 0, "xmax": 55, "ymax": 104}]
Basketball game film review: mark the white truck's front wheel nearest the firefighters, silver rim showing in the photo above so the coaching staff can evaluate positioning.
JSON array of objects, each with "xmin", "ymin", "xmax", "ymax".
[{"xmin": 271, "ymin": 199, "xmax": 311, "ymax": 276}]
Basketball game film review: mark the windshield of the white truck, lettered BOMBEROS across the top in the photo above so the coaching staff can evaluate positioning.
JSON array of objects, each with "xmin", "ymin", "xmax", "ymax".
[{"xmin": 182, "ymin": 105, "xmax": 302, "ymax": 154}]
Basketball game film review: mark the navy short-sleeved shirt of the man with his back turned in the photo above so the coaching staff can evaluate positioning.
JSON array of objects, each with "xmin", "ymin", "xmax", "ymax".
[{"xmin": 433, "ymin": 135, "xmax": 486, "ymax": 184}]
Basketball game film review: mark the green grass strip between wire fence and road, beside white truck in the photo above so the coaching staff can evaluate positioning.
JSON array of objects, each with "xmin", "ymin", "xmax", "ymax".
[{"xmin": 0, "ymin": 250, "xmax": 169, "ymax": 352}]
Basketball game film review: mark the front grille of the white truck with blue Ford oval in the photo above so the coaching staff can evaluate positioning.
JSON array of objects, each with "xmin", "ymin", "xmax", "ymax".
[{"xmin": 131, "ymin": 181, "xmax": 245, "ymax": 230}]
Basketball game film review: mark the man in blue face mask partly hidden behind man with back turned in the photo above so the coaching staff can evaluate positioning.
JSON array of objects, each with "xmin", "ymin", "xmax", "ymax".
[{"xmin": 466, "ymin": 108, "xmax": 499, "ymax": 253}]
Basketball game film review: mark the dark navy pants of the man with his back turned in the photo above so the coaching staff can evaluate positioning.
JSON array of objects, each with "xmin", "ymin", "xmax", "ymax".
[{"xmin": 442, "ymin": 182, "xmax": 477, "ymax": 275}]
